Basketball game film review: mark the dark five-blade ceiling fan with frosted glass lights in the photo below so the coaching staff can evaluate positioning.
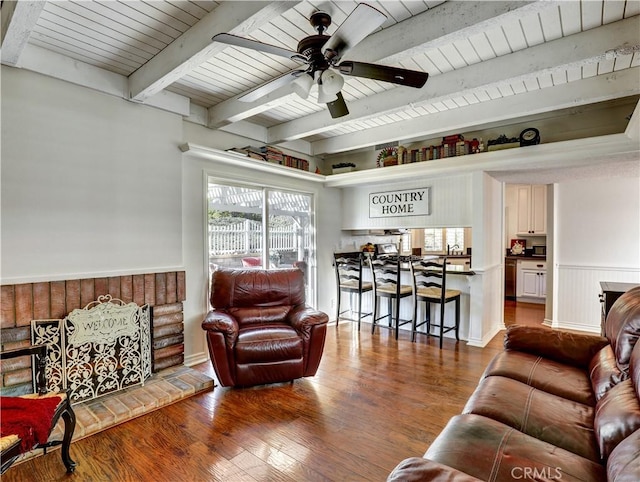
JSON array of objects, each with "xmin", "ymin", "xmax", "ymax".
[{"xmin": 212, "ymin": 3, "xmax": 429, "ymax": 119}]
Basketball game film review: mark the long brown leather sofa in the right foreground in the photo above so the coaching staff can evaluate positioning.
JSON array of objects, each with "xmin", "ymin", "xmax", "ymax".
[{"xmin": 388, "ymin": 288, "xmax": 640, "ymax": 482}]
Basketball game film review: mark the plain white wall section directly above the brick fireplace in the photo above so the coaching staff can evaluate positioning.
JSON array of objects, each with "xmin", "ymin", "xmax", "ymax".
[{"xmin": 1, "ymin": 66, "xmax": 182, "ymax": 284}]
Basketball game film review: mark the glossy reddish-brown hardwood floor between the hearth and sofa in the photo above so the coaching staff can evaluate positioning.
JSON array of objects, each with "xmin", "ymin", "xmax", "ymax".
[{"xmin": 2, "ymin": 305, "xmax": 544, "ymax": 482}]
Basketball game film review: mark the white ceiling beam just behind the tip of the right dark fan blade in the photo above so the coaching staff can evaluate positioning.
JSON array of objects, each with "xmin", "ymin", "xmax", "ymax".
[{"xmin": 269, "ymin": 16, "xmax": 640, "ymax": 143}]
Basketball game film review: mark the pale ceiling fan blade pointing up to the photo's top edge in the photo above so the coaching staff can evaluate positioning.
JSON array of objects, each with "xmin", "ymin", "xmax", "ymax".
[{"xmin": 322, "ymin": 3, "xmax": 387, "ymax": 63}]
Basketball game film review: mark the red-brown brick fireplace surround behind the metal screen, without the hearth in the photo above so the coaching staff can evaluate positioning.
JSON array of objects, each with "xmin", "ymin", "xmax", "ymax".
[{"xmin": 0, "ymin": 271, "xmax": 185, "ymax": 395}]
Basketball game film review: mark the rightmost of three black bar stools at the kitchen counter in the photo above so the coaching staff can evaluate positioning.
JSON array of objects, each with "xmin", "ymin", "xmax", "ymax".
[{"xmin": 411, "ymin": 258, "xmax": 462, "ymax": 348}]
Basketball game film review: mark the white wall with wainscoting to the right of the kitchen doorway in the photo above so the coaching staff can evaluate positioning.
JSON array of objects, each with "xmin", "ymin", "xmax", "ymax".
[{"xmin": 552, "ymin": 173, "xmax": 640, "ymax": 332}]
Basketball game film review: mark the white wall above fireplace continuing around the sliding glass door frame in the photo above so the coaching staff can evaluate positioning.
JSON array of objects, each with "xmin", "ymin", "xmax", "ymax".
[{"xmin": 0, "ymin": 66, "xmax": 341, "ymax": 362}]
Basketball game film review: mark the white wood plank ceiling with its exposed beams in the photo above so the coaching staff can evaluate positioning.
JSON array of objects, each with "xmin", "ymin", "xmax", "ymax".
[{"xmin": 2, "ymin": 0, "xmax": 640, "ymax": 155}]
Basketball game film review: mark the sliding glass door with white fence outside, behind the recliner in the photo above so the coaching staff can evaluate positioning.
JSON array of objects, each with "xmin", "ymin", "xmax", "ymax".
[{"xmin": 207, "ymin": 178, "xmax": 316, "ymax": 304}]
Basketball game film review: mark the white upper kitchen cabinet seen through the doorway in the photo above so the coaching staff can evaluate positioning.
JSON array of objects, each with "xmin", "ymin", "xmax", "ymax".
[{"xmin": 515, "ymin": 184, "xmax": 547, "ymax": 236}]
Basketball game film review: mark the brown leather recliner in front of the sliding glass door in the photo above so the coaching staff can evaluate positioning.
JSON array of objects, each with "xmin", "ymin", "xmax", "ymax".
[{"xmin": 202, "ymin": 268, "xmax": 329, "ymax": 387}]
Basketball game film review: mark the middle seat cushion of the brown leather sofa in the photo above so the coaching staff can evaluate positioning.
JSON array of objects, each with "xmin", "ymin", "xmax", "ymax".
[{"xmin": 462, "ymin": 376, "xmax": 600, "ymax": 462}]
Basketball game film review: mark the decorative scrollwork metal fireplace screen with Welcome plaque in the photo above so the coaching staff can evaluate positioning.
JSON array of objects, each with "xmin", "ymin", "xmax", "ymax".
[{"xmin": 31, "ymin": 295, "xmax": 153, "ymax": 403}]
